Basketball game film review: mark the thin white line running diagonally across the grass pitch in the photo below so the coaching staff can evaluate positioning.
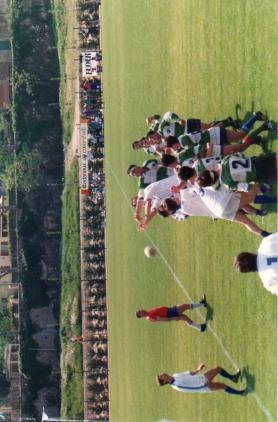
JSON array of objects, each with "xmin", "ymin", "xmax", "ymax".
[{"xmin": 106, "ymin": 160, "xmax": 278, "ymax": 422}]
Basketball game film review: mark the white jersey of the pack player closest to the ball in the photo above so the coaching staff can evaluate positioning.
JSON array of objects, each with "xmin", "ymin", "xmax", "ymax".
[{"xmin": 180, "ymin": 189, "xmax": 217, "ymax": 218}]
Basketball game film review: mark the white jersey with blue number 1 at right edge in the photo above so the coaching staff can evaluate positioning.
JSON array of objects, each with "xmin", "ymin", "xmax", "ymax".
[{"xmin": 257, "ymin": 233, "xmax": 278, "ymax": 296}]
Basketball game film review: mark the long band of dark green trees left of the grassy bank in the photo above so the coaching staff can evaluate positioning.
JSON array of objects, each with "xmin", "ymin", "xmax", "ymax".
[{"xmin": 9, "ymin": 0, "xmax": 63, "ymax": 415}]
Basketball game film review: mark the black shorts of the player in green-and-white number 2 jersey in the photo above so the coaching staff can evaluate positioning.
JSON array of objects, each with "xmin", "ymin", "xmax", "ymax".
[{"xmin": 252, "ymin": 154, "xmax": 277, "ymax": 185}]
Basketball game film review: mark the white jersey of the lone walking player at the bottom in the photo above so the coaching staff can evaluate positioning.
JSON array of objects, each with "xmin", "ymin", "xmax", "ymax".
[{"xmin": 170, "ymin": 372, "xmax": 210, "ymax": 393}]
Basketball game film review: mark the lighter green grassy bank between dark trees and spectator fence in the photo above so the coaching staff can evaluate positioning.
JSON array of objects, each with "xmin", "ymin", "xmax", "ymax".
[{"xmin": 60, "ymin": 161, "xmax": 83, "ymax": 417}]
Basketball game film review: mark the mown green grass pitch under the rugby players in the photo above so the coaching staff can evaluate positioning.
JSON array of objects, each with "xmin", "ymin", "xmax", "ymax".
[{"xmin": 101, "ymin": 0, "xmax": 278, "ymax": 422}]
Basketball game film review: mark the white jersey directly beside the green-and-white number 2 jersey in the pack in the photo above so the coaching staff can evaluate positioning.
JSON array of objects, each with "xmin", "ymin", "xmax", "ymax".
[{"xmin": 198, "ymin": 185, "xmax": 240, "ymax": 220}]
